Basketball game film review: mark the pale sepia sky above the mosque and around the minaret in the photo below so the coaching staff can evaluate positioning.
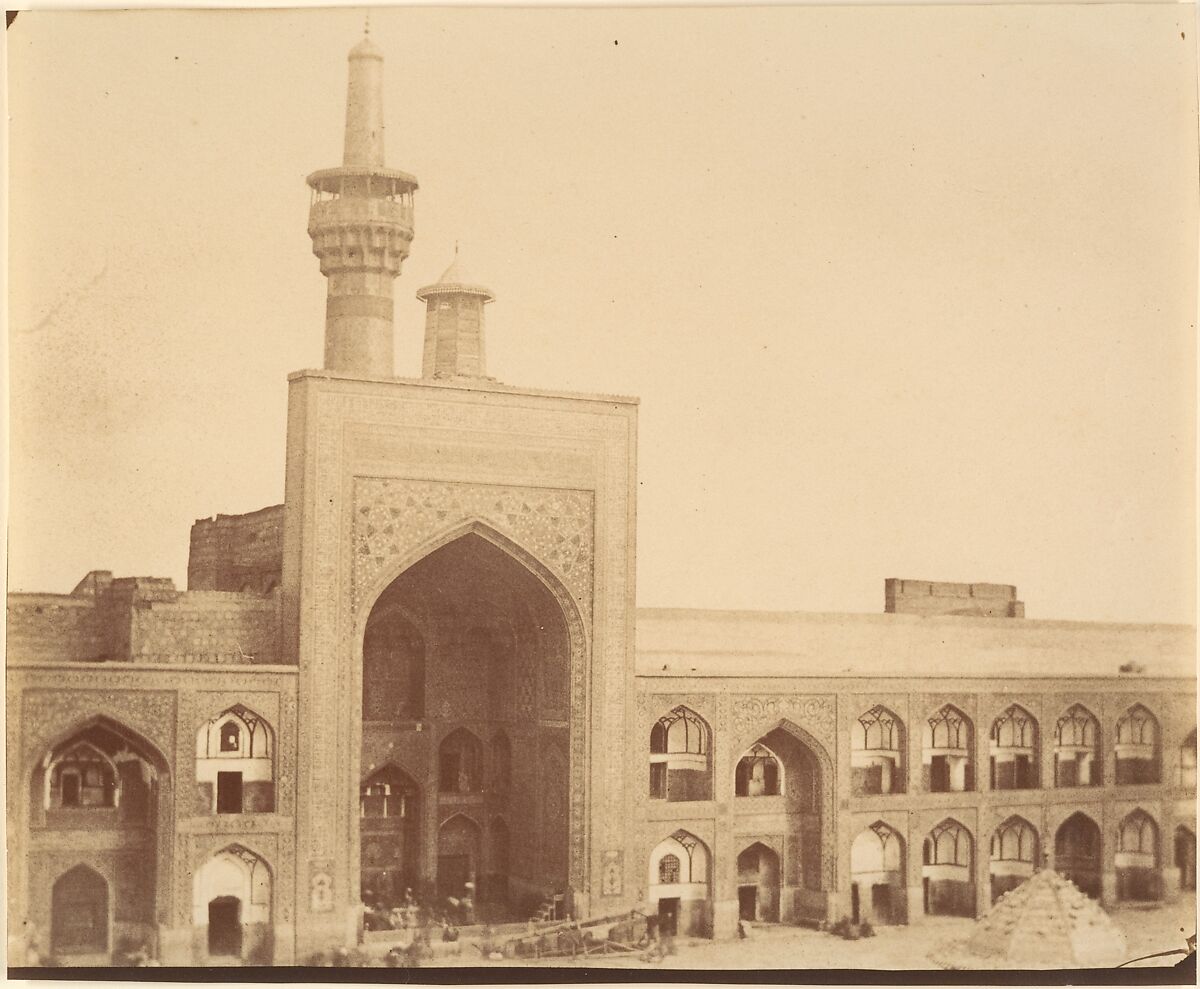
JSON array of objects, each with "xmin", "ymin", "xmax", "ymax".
[{"xmin": 8, "ymin": 4, "xmax": 1198, "ymax": 623}]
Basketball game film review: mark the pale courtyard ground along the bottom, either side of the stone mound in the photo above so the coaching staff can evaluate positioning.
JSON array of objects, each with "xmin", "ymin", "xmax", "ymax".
[{"xmin": 433, "ymin": 894, "xmax": 1196, "ymax": 971}]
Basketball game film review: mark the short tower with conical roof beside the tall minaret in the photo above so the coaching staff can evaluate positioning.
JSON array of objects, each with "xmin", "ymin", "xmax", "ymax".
[{"xmin": 416, "ymin": 245, "xmax": 496, "ymax": 378}]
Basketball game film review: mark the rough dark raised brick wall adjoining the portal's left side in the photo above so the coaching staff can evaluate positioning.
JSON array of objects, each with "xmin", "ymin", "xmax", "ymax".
[{"xmin": 187, "ymin": 505, "xmax": 283, "ymax": 593}]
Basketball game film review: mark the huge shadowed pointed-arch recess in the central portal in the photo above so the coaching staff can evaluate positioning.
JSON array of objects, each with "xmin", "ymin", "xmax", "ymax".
[{"xmin": 360, "ymin": 527, "xmax": 583, "ymax": 916}]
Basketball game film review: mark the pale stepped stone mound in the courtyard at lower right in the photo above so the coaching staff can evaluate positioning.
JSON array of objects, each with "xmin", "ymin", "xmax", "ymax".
[{"xmin": 937, "ymin": 869, "xmax": 1127, "ymax": 969}]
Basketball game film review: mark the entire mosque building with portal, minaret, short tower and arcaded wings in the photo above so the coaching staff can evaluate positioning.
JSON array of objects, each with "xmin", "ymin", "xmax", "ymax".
[{"xmin": 7, "ymin": 32, "xmax": 1195, "ymax": 965}]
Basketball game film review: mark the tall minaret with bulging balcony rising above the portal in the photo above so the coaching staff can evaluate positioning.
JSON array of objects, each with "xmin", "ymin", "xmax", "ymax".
[{"xmin": 308, "ymin": 30, "xmax": 416, "ymax": 378}]
